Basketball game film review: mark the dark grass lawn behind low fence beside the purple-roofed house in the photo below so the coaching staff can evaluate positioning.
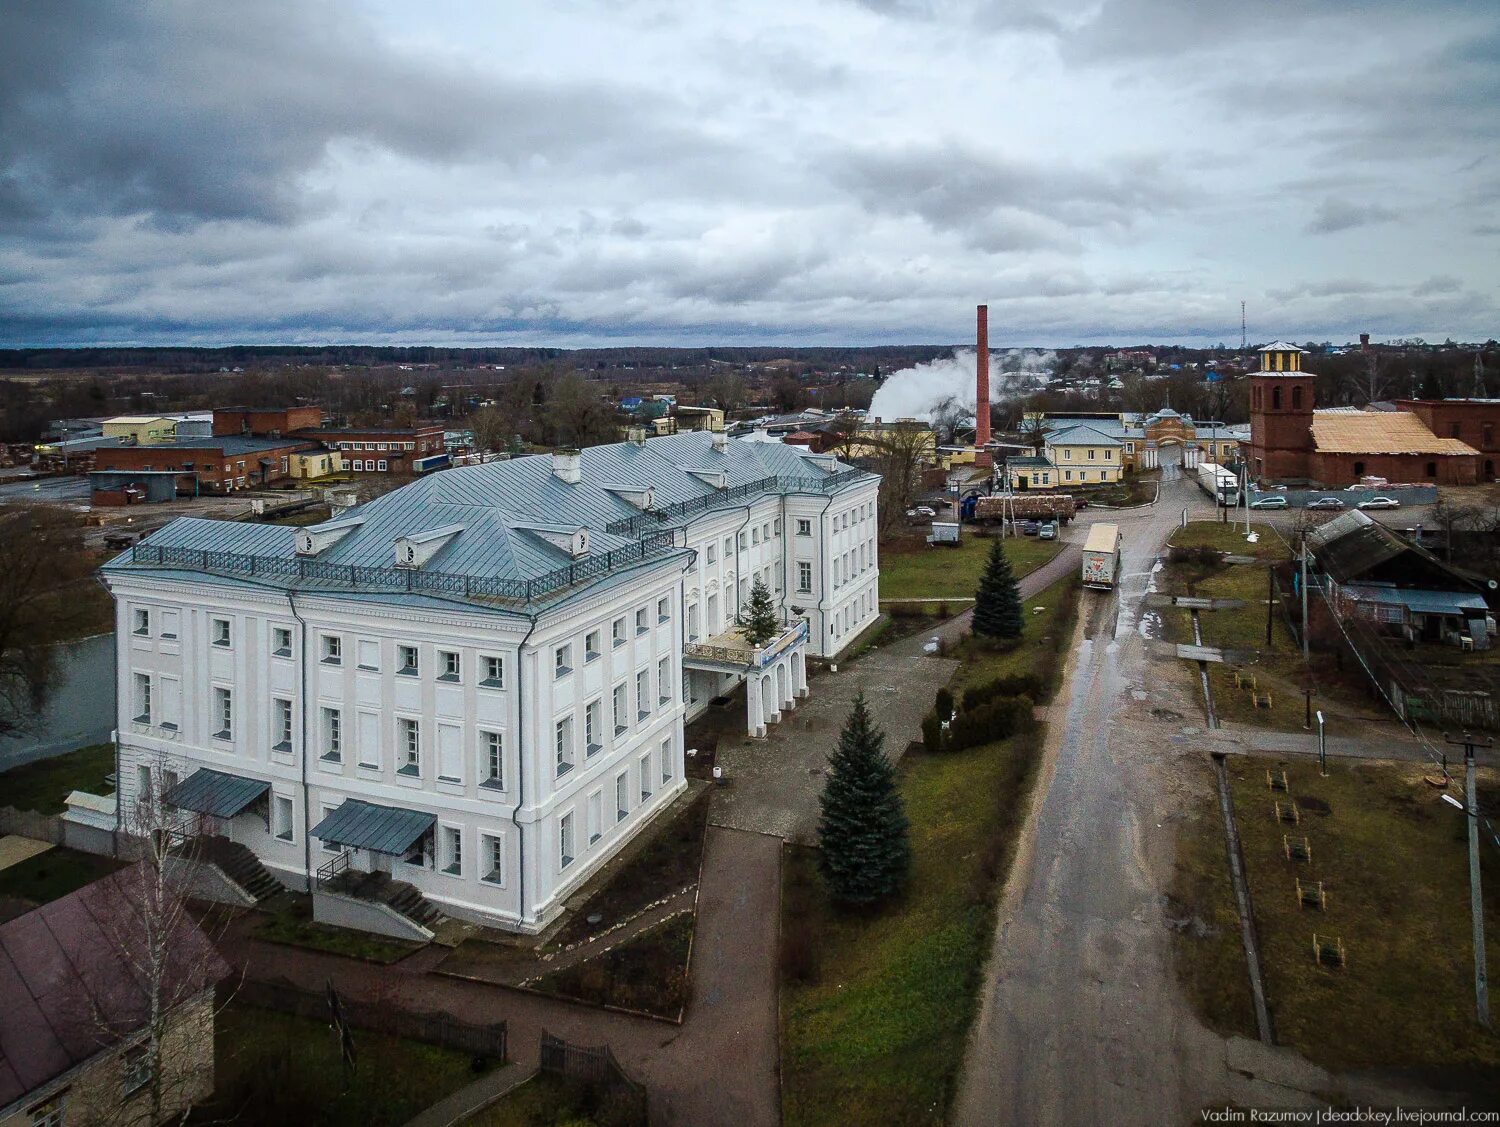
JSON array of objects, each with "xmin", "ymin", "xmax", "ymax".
[{"xmin": 194, "ymin": 1001, "xmax": 479, "ymax": 1127}]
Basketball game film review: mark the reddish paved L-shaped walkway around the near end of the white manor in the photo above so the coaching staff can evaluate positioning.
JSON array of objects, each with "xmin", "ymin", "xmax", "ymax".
[{"xmin": 222, "ymin": 827, "xmax": 782, "ymax": 1127}]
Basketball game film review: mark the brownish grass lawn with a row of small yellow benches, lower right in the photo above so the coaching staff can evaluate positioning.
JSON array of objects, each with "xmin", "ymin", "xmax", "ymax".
[{"xmin": 1229, "ymin": 758, "xmax": 1500, "ymax": 1091}]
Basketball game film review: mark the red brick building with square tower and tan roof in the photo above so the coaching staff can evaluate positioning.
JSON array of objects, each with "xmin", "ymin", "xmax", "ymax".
[{"xmin": 1250, "ymin": 341, "xmax": 1500, "ymax": 486}]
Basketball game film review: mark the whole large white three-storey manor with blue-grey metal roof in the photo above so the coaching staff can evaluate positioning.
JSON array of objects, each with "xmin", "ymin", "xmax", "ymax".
[{"xmin": 104, "ymin": 432, "xmax": 879, "ymax": 936}]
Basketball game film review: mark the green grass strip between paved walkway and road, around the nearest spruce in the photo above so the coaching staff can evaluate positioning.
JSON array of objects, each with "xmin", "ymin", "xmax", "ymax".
[{"xmin": 782, "ymin": 582, "xmax": 1077, "ymax": 1124}]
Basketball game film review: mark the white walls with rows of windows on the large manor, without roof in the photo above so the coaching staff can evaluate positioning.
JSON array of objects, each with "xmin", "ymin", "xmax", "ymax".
[{"xmin": 105, "ymin": 432, "xmax": 879, "ymax": 932}]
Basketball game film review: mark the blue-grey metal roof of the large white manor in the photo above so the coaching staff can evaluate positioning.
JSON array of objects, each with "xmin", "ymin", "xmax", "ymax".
[{"xmin": 105, "ymin": 431, "xmax": 872, "ymax": 612}]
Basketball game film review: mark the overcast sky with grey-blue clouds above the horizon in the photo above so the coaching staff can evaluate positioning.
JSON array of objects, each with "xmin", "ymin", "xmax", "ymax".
[{"xmin": 0, "ymin": 0, "xmax": 1500, "ymax": 347}]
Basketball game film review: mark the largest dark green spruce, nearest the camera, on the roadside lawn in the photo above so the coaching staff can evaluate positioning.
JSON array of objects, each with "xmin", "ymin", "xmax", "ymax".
[{"xmin": 818, "ymin": 693, "xmax": 912, "ymax": 905}]
